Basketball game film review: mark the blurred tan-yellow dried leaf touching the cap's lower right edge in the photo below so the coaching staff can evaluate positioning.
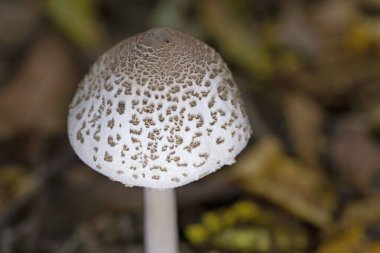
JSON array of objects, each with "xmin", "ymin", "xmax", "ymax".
[{"xmin": 231, "ymin": 137, "xmax": 335, "ymax": 227}]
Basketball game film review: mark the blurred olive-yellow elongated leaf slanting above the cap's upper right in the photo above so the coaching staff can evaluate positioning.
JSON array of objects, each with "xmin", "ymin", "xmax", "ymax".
[{"xmin": 200, "ymin": 0, "xmax": 274, "ymax": 79}]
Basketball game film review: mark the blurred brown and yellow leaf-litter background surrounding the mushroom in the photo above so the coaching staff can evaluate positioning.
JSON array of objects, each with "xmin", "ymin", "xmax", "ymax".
[{"xmin": 0, "ymin": 0, "xmax": 380, "ymax": 253}]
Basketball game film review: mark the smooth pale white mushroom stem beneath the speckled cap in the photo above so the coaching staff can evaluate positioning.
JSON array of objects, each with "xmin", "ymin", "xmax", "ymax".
[{"xmin": 144, "ymin": 188, "xmax": 178, "ymax": 253}]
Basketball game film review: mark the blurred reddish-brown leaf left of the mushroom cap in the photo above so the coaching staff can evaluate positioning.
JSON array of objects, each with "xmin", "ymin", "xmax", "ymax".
[{"xmin": 0, "ymin": 34, "xmax": 76, "ymax": 136}]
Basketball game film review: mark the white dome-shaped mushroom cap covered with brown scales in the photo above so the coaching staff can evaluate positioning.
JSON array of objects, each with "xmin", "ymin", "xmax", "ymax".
[{"xmin": 68, "ymin": 28, "xmax": 251, "ymax": 189}]
